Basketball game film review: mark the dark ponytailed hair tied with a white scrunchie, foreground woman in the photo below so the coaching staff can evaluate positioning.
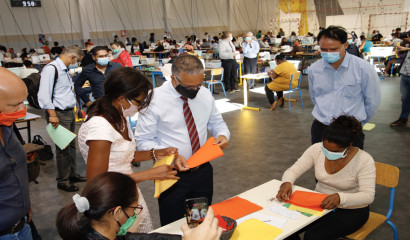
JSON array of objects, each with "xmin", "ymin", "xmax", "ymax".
[{"xmin": 56, "ymin": 172, "xmax": 138, "ymax": 240}]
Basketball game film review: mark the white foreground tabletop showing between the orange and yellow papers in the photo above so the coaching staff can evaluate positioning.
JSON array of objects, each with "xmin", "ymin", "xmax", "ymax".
[{"xmin": 153, "ymin": 179, "xmax": 330, "ymax": 240}]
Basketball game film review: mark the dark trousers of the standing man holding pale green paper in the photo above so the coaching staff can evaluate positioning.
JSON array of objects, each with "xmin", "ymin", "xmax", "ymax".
[{"xmin": 46, "ymin": 110, "xmax": 77, "ymax": 182}]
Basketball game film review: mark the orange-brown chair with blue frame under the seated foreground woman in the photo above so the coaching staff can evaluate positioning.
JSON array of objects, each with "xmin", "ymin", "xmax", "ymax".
[{"xmin": 347, "ymin": 162, "xmax": 399, "ymax": 240}]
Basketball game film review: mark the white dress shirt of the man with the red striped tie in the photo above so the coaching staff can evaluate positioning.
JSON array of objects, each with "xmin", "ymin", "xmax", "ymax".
[{"xmin": 135, "ymin": 81, "xmax": 230, "ymax": 159}]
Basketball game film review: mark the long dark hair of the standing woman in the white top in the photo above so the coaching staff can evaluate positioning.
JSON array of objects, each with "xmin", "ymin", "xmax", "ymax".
[{"xmin": 86, "ymin": 67, "xmax": 153, "ymax": 132}]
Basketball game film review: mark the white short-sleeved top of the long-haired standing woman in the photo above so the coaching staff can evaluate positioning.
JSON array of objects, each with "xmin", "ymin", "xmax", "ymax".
[{"xmin": 78, "ymin": 116, "xmax": 137, "ymax": 174}]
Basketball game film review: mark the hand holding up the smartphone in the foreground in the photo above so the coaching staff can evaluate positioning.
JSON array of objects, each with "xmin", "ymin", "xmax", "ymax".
[{"xmin": 181, "ymin": 207, "xmax": 222, "ymax": 240}]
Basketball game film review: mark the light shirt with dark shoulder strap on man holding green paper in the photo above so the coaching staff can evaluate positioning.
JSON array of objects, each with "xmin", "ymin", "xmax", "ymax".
[{"xmin": 37, "ymin": 58, "xmax": 76, "ymax": 110}]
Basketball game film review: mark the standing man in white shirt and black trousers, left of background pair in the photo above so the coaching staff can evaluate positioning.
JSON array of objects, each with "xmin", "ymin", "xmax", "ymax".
[{"xmin": 218, "ymin": 32, "xmax": 239, "ymax": 93}]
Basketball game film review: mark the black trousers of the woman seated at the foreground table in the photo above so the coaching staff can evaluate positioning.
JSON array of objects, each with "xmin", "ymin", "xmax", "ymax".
[{"xmin": 285, "ymin": 206, "xmax": 369, "ymax": 240}]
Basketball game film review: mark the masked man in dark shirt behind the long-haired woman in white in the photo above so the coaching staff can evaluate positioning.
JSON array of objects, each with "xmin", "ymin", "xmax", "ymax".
[{"xmin": 74, "ymin": 46, "xmax": 121, "ymax": 107}]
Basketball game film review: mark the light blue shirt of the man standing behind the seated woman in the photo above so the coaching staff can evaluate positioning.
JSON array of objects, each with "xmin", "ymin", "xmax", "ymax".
[{"xmin": 309, "ymin": 53, "xmax": 381, "ymax": 125}]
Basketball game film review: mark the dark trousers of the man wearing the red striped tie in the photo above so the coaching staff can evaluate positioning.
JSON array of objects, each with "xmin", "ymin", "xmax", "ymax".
[{"xmin": 158, "ymin": 163, "xmax": 213, "ymax": 226}]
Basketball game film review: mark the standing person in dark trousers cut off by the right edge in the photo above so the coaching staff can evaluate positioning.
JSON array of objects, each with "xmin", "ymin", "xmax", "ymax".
[{"xmin": 390, "ymin": 32, "xmax": 410, "ymax": 127}]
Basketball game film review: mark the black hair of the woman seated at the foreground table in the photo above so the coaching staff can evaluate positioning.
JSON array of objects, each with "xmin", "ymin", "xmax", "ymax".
[{"xmin": 322, "ymin": 115, "xmax": 363, "ymax": 148}]
